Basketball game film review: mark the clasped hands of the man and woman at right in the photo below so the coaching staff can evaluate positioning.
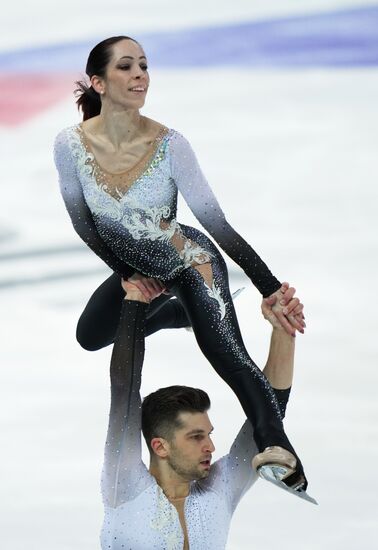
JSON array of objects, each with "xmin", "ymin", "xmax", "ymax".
[{"xmin": 261, "ymin": 283, "xmax": 306, "ymax": 336}]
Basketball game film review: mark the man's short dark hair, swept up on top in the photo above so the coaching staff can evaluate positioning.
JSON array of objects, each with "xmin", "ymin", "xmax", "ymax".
[{"xmin": 142, "ymin": 386, "xmax": 210, "ymax": 452}]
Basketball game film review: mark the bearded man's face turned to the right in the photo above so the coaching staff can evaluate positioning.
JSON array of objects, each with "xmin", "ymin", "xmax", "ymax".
[{"xmin": 167, "ymin": 412, "xmax": 215, "ymax": 481}]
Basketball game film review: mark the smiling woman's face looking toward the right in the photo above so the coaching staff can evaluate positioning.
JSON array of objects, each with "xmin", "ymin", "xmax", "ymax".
[{"xmin": 96, "ymin": 40, "xmax": 150, "ymax": 109}]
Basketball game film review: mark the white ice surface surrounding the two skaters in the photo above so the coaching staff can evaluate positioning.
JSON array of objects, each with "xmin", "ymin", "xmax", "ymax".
[{"xmin": 0, "ymin": 0, "xmax": 378, "ymax": 550}]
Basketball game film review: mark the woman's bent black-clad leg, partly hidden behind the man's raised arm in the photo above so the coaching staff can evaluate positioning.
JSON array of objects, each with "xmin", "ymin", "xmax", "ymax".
[{"xmin": 76, "ymin": 273, "xmax": 190, "ymax": 351}]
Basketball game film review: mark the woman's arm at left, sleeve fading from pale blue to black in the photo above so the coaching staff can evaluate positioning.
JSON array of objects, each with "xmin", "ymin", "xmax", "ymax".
[{"xmin": 54, "ymin": 130, "xmax": 135, "ymax": 279}]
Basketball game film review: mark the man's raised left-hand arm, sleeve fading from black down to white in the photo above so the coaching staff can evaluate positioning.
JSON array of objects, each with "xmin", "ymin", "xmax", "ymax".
[{"xmin": 101, "ymin": 300, "xmax": 148, "ymax": 508}]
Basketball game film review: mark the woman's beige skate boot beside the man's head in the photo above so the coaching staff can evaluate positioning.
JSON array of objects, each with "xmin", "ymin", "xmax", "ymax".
[{"xmin": 252, "ymin": 446, "xmax": 307, "ymax": 491}]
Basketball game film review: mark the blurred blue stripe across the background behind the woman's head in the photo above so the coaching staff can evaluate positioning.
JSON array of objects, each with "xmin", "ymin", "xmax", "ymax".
[{"xmin": 0, "ymin": 5, "xmax": 378, "ymax": 73}]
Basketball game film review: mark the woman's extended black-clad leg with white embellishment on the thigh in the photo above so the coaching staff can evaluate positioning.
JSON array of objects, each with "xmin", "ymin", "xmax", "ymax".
[{"xmin": 169, "ymin": 253, "xmax": 302, "ymax": 466}]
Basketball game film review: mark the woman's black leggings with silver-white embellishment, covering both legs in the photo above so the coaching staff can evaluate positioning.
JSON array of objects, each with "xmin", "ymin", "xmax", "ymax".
[{"xmin": 77, "ymin": 239, "xmax": 297, "ymax": 468}]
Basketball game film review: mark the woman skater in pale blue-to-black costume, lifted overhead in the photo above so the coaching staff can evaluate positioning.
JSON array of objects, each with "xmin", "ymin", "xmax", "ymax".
[{"xmin": 55, "ymin": 36, "xmax": 307, "ymax": 490}]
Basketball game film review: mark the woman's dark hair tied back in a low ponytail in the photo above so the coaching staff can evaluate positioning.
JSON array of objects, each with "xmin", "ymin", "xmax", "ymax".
[{"xmin": 74, "ymin": 36, "xmax": 139, "ymax": 120}]
